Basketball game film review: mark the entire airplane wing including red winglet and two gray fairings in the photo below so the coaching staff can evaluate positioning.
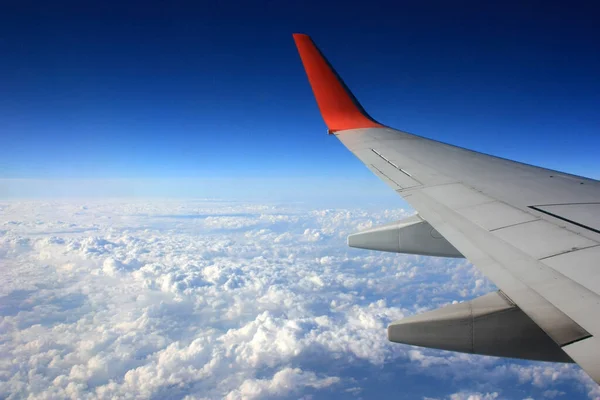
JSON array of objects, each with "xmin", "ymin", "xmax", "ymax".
[{"xmin": 294, "ymin": 34, "xmax": 600, "ymax": 383}]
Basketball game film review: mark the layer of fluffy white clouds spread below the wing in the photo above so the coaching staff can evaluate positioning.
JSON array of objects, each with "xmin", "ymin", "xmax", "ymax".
[{"xmin": 0, "ymin": 200, "xmax": 600, "ymax": 400}]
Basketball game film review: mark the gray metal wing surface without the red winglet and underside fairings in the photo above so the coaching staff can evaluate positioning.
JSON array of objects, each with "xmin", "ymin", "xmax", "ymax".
[{"xmin": 335, "ymin": 128, "xmax": 600, "ymax": 382}]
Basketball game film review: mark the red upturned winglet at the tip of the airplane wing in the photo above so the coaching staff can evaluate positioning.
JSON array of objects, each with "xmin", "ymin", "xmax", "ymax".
[{"xmin": 293, "ymin": 33, "xmax": 383, "ymax": 133}]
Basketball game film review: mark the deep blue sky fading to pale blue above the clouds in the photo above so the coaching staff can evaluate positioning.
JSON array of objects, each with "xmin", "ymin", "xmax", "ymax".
[{"xmin": 0, "ymin": 1, "xmax": 600, "ymax": 197}]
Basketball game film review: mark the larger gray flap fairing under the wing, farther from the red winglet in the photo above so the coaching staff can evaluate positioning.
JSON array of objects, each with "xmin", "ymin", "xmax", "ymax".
[{"xmin": 388, "ymin": 292, "xmax": 572, "ymax": 362}]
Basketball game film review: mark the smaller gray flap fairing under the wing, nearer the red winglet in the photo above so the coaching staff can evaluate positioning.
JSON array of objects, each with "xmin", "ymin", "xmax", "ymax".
[{"xmin": 348, "ymin": 215, "xmax": 463, "ymax": 258}]
